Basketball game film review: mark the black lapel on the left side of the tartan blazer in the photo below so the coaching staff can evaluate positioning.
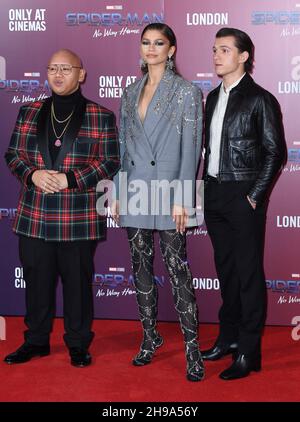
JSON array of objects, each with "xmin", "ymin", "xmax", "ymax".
[{"xmin": 37, "ymin": 97, "xmax": 52, "ymax": 170}]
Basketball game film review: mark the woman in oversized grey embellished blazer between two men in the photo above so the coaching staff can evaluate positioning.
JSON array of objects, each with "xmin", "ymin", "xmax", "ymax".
[{"xmin": 112, "ymin": 23, "xmax": 204, "ymax": 381}]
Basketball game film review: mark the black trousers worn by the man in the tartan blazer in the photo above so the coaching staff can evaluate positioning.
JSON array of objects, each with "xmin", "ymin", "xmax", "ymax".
[{"xmin": 19, "ymin": 236, "xmax": 97, "ymax": 348}]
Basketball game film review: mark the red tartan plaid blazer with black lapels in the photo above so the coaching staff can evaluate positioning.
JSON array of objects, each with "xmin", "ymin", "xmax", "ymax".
[{"xmin": 5, "ymin": 97, "xmax": 120, "ymax": 241}]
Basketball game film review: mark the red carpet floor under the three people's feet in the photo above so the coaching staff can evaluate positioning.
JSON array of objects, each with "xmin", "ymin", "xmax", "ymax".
[{"xmin": 0, "ymin": 317, "xmax": 300, "ymax": 402}]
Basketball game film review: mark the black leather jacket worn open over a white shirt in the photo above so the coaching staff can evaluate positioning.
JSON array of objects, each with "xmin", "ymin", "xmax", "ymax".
[{"xmin": 203, "ymin": 73, "xmax": 286, "ymax": 202}]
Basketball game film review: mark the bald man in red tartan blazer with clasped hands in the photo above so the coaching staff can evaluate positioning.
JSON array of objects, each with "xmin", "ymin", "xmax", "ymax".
[{"xmin": 5, "ymin": 50, "xmax": 119, "ymax": 367}]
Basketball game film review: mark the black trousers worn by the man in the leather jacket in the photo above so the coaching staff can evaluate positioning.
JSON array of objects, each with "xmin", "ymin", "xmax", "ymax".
[{"xmin": 204, "ymin": 178, "xmax": 266, "ymax": 355}]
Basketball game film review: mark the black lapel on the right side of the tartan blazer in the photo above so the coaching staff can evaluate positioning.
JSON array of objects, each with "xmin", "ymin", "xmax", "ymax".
[{"xmin": 53, "ymin": 97, "xmax": 86, "ymax": 170}]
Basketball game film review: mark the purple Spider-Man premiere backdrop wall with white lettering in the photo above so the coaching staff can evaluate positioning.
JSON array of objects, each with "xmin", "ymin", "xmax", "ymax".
[{"xmin": 0, "ymin": 0, "xmax": 300, "ymax": 325}]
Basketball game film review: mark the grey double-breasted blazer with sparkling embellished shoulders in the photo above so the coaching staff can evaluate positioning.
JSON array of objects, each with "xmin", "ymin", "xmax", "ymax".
[{"xmin": 114, "ymin": 70, "xmax": 202, "ymax": 230}]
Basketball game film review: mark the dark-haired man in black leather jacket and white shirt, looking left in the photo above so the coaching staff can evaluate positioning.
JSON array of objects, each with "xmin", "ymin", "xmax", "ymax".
[{"xmin": 203, "ymin": 28, "xmax": 286, "ymax": 380}]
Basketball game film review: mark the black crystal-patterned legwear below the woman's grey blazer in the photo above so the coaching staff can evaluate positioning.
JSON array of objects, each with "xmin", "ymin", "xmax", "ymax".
[{"xmin": 127, "ymin": 227, "xmax": 204, "ymax": 381}]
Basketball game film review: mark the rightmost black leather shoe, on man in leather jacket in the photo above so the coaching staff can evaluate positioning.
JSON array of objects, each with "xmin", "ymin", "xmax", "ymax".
[{"xmin": 219, "ymin": 353, "xmax": 261, "ymax": 381}]
